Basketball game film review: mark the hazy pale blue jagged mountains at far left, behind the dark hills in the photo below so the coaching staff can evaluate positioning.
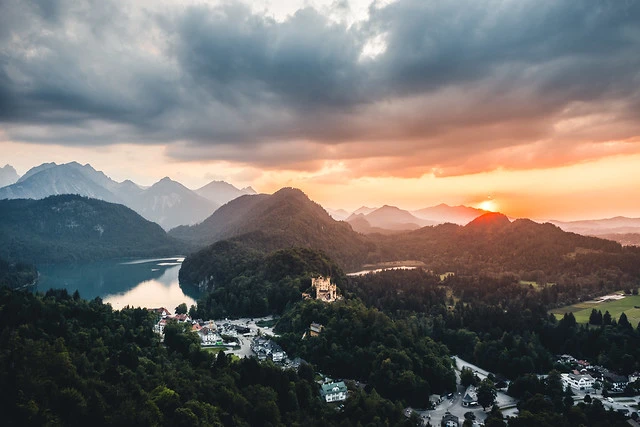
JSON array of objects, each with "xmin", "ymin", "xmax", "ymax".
[{"xmin": 0, "ymin": 162, "xmax": 255, "ymax": 230}]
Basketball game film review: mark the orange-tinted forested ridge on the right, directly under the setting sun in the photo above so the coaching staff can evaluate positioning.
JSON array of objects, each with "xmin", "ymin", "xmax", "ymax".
[{"xmin": 370, "ymin": 213, "xmax": 640, "ymax": 275}]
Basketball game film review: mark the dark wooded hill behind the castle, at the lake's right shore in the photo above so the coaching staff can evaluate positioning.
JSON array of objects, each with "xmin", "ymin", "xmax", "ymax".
[{"xmin": 180, "ymin": 241, "xmax": 344, "ymax": 319}]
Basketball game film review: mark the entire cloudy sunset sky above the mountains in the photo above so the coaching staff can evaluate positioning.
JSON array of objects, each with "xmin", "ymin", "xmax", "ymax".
[{"xmin": 0, "ymin": 0, "xmax": 640, "ymax": 220}]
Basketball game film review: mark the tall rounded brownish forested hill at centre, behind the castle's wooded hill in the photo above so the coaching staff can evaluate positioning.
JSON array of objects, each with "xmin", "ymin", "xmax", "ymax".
[{"xmin": 169, "ymin": 188, "xmax": 374, "ymax": 269}]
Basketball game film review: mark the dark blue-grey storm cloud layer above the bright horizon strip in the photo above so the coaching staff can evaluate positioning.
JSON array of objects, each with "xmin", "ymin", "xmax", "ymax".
[{"xmin": 0, "ymin": 0, "xmax": 640, "ymax": 175}]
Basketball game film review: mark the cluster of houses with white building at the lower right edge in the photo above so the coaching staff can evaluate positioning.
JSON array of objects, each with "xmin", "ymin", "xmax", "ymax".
[{"xmin": 558, "ymin": 354, "xmax": 640, "ymax": 393}]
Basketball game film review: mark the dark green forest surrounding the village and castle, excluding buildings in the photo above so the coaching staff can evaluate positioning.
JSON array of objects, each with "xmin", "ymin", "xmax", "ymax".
[{"xmin": 0, "ymin": 243, "xmax": 640, "ymax": 426}]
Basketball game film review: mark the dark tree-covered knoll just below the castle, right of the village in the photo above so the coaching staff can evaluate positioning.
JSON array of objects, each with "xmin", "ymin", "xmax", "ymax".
[{"xmin": 277, "ymin": 299, "xmax": 455, "ymax": 407}]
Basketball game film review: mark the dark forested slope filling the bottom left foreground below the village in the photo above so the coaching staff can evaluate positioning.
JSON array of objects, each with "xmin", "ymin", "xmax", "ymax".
[{"xmin": 0, "ymin": 288, "xmax": 416, "ymax": 427}]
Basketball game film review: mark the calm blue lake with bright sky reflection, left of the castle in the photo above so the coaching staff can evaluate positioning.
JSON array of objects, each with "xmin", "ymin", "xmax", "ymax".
[{"xmin": 36, "ymin": 257, "xmax": 200, "ymax": 312}]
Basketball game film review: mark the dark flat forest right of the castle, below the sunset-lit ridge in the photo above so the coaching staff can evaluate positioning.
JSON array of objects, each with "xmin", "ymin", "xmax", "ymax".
[{"xmin": 345, "ymin": 270, "xmax": 640, "ymax": 378}]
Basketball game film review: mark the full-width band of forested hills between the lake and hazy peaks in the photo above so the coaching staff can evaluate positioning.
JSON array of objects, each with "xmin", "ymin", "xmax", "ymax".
[{"xmin": 0, "ymin": 179, "xmax": 640, "ymax": 286}]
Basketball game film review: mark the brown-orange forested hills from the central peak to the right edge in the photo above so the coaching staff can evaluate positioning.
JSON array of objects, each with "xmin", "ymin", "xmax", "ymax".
[{"xmin": 175, "ymin": 188, "xmax": 640, "ymax": 290}]
